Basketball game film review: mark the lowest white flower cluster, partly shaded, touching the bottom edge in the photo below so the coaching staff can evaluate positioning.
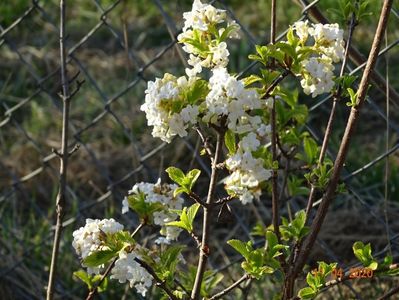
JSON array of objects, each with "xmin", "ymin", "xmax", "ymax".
[{"xmin": 111, "ymin": 250, "xmax": 152, "ymax": 297}]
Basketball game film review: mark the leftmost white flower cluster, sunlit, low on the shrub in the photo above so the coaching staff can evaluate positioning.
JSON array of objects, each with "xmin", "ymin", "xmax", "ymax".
[{"xmin": 72, "ymin": 219, "xmax": 123, "ymax": 274}]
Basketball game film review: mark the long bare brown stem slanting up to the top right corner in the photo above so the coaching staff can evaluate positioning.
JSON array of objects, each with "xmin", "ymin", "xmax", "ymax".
[{"xmin": 292, "ymin": 0, "xmax": 393, "ymax": 299}]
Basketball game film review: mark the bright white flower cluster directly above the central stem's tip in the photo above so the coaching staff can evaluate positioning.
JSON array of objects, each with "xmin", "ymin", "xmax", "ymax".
[{"xmin": 202, "ymin": 68, "xmax": 262, "ymax": 134}]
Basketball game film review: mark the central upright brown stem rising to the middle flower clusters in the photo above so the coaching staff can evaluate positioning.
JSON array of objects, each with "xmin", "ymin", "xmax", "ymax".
[{"xmin": 191, "ymin": 122, "xmax": 225, "ymax": 300}]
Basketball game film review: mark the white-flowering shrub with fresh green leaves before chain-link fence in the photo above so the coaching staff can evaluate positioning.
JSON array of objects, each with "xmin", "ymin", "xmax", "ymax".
[{"xmin": 73, "ymin": 0, "xmax": 397, "ymax": 300}]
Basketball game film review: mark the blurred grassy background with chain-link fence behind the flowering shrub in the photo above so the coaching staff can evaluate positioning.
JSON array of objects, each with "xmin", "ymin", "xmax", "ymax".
[{"xmin": 0, "ymin": 0, "xmax": 399, "ymax": 299}]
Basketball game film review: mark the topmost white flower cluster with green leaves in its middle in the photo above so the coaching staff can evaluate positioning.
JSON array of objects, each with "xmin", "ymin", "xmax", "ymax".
[{"xmin": 177, "ymin": 0, "xmax": 239, "ymax": 77}]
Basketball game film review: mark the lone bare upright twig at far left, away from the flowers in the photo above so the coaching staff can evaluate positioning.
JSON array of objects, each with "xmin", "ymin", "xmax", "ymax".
[{"xmin": 46, "ymin": 0, "xmax": 71, "ymax": 300}]
